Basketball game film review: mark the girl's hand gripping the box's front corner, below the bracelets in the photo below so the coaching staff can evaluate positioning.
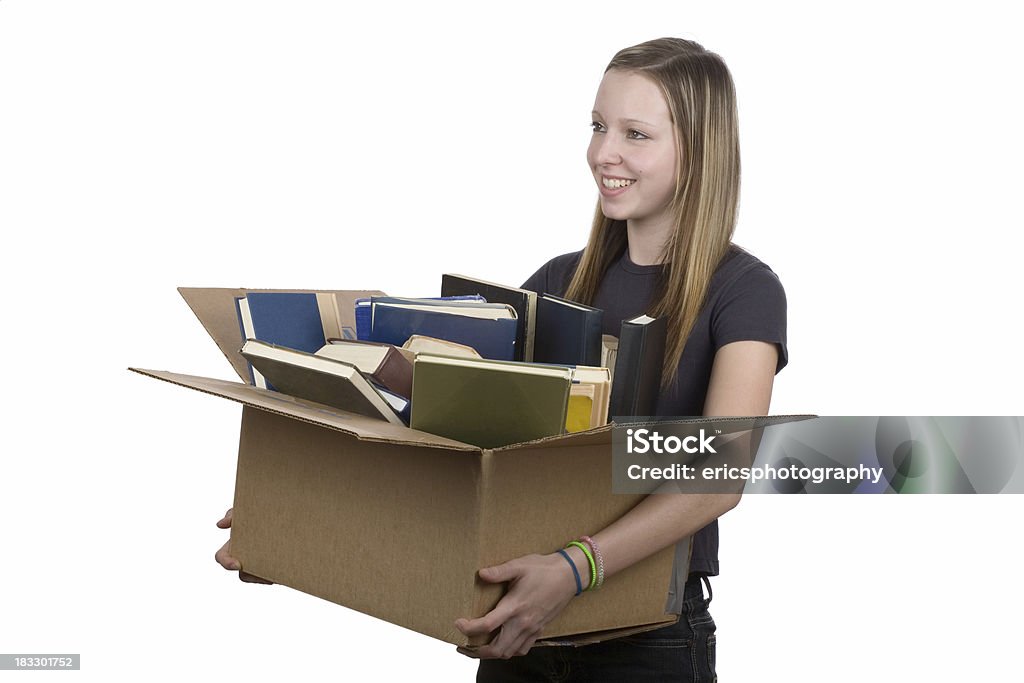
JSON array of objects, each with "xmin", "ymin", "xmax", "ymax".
[{"xmin": 455, "ymin": 553, "xmax": 575, "ymax": 659}]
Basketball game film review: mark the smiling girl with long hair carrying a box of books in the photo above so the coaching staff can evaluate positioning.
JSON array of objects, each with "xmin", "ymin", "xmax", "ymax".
[{"xmin": 456, "ymin": 38, "xmax": 787, "ymax": 682}]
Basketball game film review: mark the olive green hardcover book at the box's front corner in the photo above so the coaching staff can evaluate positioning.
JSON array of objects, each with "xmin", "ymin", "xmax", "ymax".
[{"xmin": 410, "ymin": 355, "xmax": 572, "ymax": 449}]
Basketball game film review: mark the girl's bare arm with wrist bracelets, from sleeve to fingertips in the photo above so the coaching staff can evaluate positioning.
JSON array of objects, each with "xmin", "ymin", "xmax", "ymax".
[{"xmin": 456, "ymin": 341, "xmax": 778, "ymax": 658}]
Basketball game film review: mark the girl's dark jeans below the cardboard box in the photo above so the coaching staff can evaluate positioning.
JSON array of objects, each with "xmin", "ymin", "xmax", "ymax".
[{"xmin": 476, "ymin": 577, "xmax": 718, "ymax": 683}]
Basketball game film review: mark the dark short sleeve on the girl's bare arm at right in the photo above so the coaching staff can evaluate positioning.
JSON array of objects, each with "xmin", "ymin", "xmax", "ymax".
[{"xmin": 711, "ymin": 262, "xmax": 790, "ymax": 373}]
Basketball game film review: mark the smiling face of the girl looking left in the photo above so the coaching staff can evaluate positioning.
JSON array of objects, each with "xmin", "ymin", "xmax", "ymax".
[{"xmin": 587, "ymin": 69, "xmax": 679, "ymax": 236}]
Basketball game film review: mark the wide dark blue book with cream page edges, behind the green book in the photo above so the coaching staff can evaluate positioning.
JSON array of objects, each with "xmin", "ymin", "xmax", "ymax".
[{"xmin": 370, "ymin": 297, "xmax": 518, "ymax": 360}]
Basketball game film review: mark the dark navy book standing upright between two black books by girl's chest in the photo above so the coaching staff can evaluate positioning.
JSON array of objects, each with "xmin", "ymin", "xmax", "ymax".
[{"xmin": 534, "ymin": 294, "xmax": 604, "ymax": 366}]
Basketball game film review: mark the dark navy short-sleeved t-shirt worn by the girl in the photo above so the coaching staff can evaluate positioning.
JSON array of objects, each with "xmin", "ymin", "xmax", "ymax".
[{"xmin": 522, "ymin": 246, "xmax": 788, "ymax": 612}]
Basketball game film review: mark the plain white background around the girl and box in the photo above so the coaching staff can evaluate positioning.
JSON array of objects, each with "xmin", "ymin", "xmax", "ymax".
[{"xmin": 0, "ymin": 0, "xmax": 1024, "ymax": 681}]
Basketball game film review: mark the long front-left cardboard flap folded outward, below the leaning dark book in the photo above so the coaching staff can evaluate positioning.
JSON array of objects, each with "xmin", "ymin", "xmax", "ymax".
[{"xmin": 128, "ymin": 368, "xmax": 480, "ymax": 453}]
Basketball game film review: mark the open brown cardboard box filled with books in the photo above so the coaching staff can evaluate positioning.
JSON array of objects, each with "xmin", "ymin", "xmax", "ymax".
[{"xmin": 133, "ymin": 289, "xmax": 676, "ymax": 647}]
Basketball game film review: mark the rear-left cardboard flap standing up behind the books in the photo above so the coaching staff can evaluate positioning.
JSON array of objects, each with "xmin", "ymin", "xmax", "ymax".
[{"xmin": 178, "ymin": 287, "xmax": 384, "ymax": 382}]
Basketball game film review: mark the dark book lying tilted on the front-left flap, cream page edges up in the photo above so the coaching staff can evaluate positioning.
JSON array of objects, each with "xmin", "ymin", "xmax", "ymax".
[{"xmin": 242, "ymin": 339, "xmax": 404, "ymax": 425}]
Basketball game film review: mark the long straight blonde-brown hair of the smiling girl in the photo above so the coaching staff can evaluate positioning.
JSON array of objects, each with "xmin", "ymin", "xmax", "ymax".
[{"xmin": 565, "ymin": 38, "xmax": 739, "ymax": 388}]
